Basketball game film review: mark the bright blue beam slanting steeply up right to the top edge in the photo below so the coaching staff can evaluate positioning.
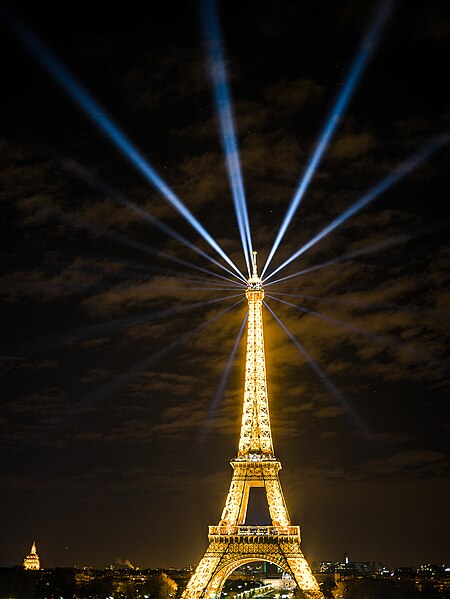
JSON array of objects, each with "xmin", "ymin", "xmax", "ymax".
[{"xmin": 261, "ymin": 0, "xmax": 393, "ymax": 278}]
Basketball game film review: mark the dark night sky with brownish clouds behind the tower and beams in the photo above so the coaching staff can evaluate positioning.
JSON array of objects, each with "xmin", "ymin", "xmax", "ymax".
[{"xmin": 0, "ymin": 0, "xmax": 450, "ymax": 567}]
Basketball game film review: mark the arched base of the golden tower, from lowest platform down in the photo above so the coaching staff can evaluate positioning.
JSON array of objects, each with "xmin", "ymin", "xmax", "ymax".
[{"xmin": 182, "ymin": 526, "xmax": 323, "ymax": 599}]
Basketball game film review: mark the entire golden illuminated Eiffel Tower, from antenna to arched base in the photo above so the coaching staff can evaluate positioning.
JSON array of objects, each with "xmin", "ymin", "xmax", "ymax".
[{"xmin": 182, "ymin": 252, "xmax": 323, "ymax": 599}]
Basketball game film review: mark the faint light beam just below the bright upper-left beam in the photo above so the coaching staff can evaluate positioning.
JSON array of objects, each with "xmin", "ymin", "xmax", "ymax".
[{"xmin": 58, "ymin": 159, "xmax": 246, "ymax": 283}]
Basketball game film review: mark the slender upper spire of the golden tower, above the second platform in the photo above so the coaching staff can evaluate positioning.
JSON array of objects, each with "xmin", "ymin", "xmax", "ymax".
[{"xmin": 238, "ymin": 252, "xmax": 274, "ymax": 460}]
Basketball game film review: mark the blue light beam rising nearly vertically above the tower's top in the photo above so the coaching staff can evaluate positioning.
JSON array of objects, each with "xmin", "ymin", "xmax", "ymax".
[{"xmin": 201, "ymin": 0, "xmax": 253, "ymax": 276}]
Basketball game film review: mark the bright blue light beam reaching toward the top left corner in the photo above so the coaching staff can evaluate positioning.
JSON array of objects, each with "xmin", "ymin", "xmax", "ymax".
[{"xmin": 9, "ymin": 15, "xmax": 247, "ymax": 283}]
